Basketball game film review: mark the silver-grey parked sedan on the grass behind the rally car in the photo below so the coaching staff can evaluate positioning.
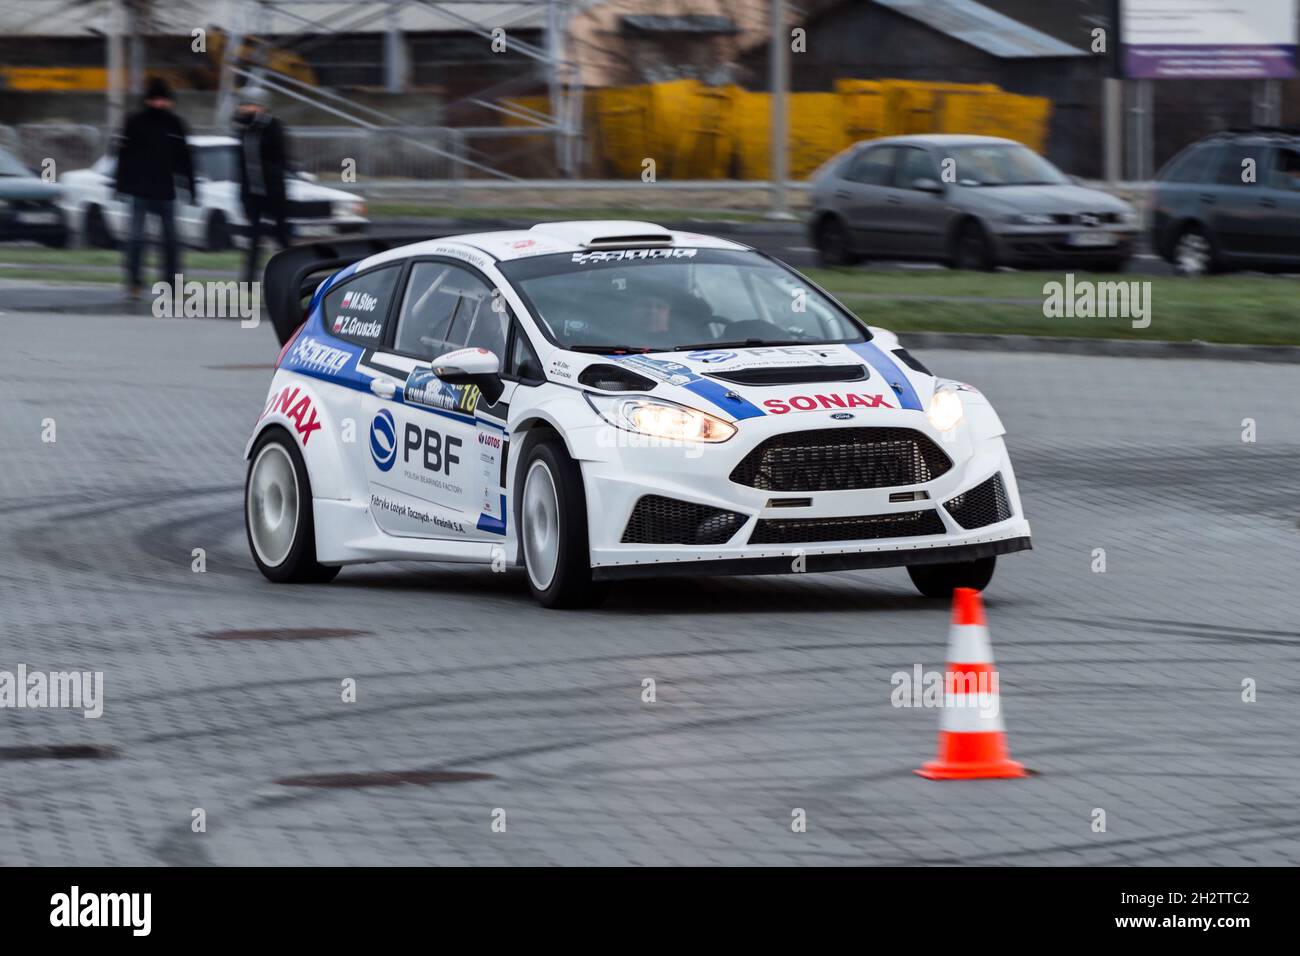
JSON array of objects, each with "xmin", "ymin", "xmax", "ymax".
[{"xmin": 810, "ymin": 134, "xmax": 1138, "ymax": 272}]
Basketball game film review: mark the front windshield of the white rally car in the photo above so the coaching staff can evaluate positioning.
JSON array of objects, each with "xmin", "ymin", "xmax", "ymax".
[{"xmin": 502, "ymin": 248, "xmax": 867, "ymax": 352}]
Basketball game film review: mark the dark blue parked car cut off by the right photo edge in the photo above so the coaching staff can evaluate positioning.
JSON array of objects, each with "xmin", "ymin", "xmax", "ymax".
[{"xmin": 1148, "ymin": 129, "xmax": 1300, "ymax": 276}]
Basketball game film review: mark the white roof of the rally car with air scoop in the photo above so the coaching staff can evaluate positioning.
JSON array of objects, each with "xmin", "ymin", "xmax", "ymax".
[{"xmin": 356, "ymin": 220, "xmax": 750, "ymax": 271}]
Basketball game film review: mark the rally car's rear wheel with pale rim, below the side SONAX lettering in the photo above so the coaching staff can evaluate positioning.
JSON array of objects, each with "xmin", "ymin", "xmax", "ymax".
[{"xmin": 244, "ymin": 428, "xmax": 339, "ymax": 584}]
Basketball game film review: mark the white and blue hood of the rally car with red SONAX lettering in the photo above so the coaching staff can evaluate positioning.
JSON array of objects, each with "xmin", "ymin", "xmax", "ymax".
[{"xmin": 569, "ymin": 341, "xmax": 935, "ymax": 420}]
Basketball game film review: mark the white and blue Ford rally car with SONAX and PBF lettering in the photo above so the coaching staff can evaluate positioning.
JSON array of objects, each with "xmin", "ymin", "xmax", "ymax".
[{"xmin": 244, "ymin": 221, "xmax": 1030, "ymax": 607}]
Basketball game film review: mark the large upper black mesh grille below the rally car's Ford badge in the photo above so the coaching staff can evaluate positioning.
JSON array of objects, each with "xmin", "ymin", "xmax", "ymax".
[{"xmin": 731, "ymin": 428, "xmax": 953, "ymax": 492}]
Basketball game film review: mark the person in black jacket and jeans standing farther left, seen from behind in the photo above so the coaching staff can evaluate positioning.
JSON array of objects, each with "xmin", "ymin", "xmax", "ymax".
[{"xmin": 114, "ymin": 77, "xmax": 196, "ymax": 299}]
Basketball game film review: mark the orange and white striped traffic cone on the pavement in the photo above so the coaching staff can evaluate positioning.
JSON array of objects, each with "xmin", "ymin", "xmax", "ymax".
[{"xmin": 915, "ymin": 588, "xmax": 1027, "ymax": 780}]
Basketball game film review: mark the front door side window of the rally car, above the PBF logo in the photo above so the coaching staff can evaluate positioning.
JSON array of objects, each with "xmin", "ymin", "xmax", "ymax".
[{"xmin": 395, "ymin": 261, "xmax": 510, "ymax": 359}]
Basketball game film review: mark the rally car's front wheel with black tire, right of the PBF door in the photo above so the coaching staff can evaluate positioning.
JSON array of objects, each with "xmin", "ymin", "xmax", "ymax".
[{"xmin": 516, "ymin": 436, "xmax": 608, "ymax": 607}]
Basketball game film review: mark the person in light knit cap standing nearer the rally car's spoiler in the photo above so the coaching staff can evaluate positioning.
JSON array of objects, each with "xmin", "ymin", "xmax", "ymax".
[{"xmin": 235, "ymin": 86, "xmax": 289, "ymax": 282}]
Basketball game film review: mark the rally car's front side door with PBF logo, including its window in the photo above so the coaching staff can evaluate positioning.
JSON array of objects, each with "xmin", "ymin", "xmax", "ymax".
[{"xmin": 361, "ymin": 259, "xmax": 510, "ymax": 541}]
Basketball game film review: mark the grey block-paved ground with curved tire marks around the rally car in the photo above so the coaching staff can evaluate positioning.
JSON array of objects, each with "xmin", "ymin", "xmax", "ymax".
[{"xmin": 0, "ymin": 310, "xmax": 1300, "ymax": 865}]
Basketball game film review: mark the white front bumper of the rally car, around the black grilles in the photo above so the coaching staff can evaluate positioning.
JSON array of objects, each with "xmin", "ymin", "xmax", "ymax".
[{"xmin": 581, "ymin": 411, "xmax": 1030, "ymax": 579}]
